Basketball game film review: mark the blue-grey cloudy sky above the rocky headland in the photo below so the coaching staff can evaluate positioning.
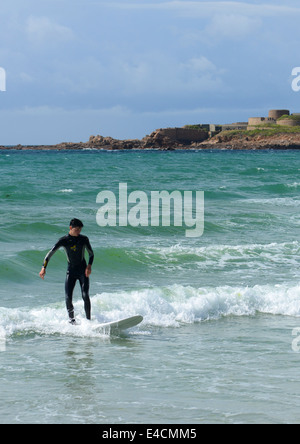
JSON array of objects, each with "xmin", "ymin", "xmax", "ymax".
[{"xmin": 0, "ymin": 0, "xmax": 300, "ymax": 145}]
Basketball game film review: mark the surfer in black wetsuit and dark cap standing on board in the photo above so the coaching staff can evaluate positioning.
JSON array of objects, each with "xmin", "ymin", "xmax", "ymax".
[{"xmin": 39, "ymin": 219, "xmax": 94, "ymax": 324}]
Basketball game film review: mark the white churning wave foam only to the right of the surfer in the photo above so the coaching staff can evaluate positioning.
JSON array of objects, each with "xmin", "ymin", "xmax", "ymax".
[{"xmin": 95, "ymin": 285, "xmax": 300, "ymax": 327}]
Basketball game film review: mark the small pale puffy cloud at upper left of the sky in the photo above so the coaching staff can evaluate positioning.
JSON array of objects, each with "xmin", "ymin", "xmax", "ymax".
[{"xmin": 25, "ymin": 16, "xmax": 74, "ymax": 45}]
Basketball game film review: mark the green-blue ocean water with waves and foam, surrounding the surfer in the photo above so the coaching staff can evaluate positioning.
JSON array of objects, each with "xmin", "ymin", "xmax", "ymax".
[{"xmin": 0, "ymin": 150, "xmax": 300, "ymax": 424}]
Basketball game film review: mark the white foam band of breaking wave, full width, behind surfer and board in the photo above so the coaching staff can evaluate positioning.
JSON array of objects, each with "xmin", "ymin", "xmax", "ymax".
[{"xmin": 0, "ymin": 285, "xmax": 300, "ymax": 339}]
